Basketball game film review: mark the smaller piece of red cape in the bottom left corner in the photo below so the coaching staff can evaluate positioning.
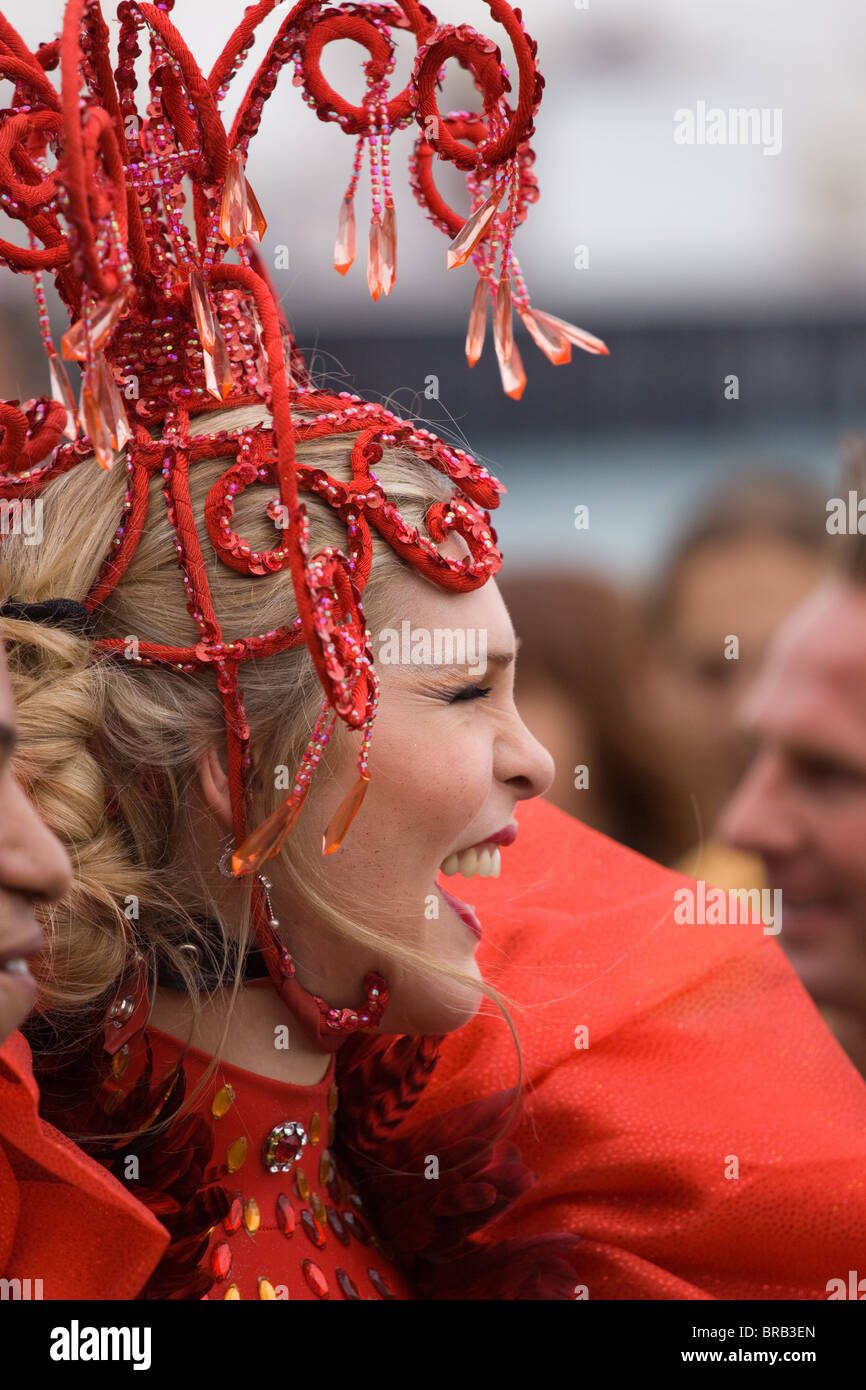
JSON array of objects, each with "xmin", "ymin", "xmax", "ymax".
[{"xmin": 0, "ymin": 1033, "xmax": 170, "ymax": 1300}]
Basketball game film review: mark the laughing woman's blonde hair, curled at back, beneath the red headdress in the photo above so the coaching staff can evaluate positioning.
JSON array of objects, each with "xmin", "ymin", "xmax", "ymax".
[{"xmin": 0, "ymin": 407, "xmax": 520, "ymax": 1134}]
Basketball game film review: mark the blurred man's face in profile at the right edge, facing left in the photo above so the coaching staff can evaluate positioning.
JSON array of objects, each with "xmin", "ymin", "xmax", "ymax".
[{"xmin": 719, "ymin": 581, "xmax": 866, "ymax": 1013}]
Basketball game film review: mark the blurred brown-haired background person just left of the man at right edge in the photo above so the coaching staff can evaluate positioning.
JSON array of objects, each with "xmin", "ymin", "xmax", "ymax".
[{"xmin": 627, "ymin": 473, "xmax": 827, "ymax": 888}]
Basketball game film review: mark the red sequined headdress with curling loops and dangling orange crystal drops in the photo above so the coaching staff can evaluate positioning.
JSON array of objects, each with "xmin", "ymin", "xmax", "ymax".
[{"xmin": 0, "ymin": 0, "xmax": 607, "ymax": 1038}]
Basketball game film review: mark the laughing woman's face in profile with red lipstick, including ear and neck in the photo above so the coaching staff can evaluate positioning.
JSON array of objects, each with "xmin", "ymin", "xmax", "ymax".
[{"xmin": 278, "ymin": 550, "xmax": 553, "ymax": 1034}]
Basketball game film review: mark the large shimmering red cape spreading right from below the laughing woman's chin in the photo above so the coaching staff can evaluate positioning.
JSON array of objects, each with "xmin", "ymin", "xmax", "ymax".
[{"xmin": 406, "ymin": 801, "xmax": 866, "ymax": 1300}]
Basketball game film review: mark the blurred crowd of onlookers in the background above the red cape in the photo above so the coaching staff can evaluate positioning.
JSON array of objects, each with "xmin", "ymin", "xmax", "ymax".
[{"xmin": 500, "ymin": 438, "xmax": 866, "ymax": 1074}]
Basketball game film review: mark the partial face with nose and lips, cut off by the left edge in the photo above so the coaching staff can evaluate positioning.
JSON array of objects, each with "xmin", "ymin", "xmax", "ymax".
[{"xmin": 0, "ymin": 641, "xmax": 72, "ymax": 1043}]
